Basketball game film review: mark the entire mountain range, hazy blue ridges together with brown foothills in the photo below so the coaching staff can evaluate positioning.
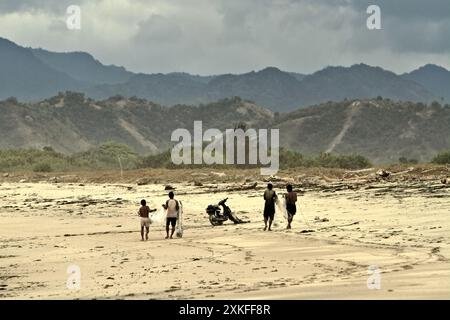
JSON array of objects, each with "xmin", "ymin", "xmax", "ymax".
[{"xmin": 0, "ymin": 38, "xmax": 450, "ymax": 163}]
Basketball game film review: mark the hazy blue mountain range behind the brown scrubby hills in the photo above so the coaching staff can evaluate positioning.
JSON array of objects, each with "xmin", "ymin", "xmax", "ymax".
[{"xmin": 0, "ymin": 38, "xmax": 450, "ymax": 112}]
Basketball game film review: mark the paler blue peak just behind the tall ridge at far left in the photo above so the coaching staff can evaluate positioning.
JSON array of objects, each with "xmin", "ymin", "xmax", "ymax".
[{"xmin": 31, "ymin": 49, "xmax": 133, "ymax": 84}]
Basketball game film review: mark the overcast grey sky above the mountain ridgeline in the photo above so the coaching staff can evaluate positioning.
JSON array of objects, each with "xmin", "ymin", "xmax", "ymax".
[{"xmin": 0, "ymin": 0, "xmax": 450, "ymax": 74}]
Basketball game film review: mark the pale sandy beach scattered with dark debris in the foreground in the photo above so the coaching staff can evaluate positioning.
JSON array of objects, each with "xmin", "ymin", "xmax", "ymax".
[{"xmin": 0, "ymin": 173, "xmax": 450, "ymax": 299}]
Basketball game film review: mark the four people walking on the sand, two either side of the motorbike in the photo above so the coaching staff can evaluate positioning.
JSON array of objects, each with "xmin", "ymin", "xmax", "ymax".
[{"xmin": 138, "ymin": 183, "xmax": 297, "ymax": 241}]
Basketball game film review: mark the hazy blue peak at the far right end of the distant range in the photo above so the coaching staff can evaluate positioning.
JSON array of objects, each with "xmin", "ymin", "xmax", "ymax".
[{"xmin": 402, "ymin": 64, "xmax": 450, "ymax": 102}]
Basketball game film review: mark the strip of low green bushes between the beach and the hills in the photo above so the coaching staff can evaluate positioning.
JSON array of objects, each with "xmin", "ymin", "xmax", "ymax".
[{"xmin": 0, "ymin": 142, "xmax": 371, "ymax": 173}]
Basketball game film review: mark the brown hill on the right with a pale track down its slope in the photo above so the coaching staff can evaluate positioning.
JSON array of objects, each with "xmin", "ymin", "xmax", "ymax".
[{"xmin": 273, "ymin": 98, "xmax": 450, "ymax": 163}]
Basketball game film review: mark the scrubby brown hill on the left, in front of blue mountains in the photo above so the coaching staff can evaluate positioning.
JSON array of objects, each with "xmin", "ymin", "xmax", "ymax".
[{"xmin": 0, "ymin": 92, "xmax": 273, "ymax": 154}]
